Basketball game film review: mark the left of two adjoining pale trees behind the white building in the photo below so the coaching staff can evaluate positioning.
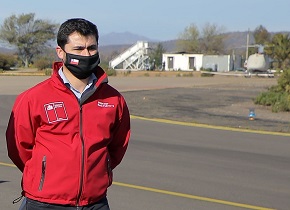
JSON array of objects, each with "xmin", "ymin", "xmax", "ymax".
[{"xmin": 176, "ymin": 24, "xmax": 199, "ymax": 53}]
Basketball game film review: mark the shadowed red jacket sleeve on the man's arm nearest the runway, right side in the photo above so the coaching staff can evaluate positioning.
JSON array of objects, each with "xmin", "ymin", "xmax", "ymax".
[{"xmin": 108, "ymin": 97, "xmax": 131, "ymax": 169}]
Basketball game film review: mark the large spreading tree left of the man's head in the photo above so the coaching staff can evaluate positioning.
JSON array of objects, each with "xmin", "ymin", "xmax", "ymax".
[{"xmin": 0, "ymin": 13, "xmax": 58, "ymax": 67}]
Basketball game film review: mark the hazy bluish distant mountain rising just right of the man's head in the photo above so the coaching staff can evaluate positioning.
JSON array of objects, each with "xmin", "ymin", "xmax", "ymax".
[{"xmin": 99, "ymin": 32, "xmax": 158, "ymax": 46}]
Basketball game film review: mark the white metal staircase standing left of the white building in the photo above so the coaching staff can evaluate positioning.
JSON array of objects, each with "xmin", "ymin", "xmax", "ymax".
[{"xmin": 109, "ymin": 41, "xmax": 149, "ymax": 70}]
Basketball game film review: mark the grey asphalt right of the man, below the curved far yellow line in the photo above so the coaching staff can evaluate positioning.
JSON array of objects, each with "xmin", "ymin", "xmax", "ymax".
[{"xmin": 111, "ymin": 119, "xmax": 290, "ymax": 210}]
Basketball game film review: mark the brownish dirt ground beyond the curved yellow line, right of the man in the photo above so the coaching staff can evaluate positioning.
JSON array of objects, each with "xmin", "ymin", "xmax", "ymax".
[{"xmin": 119, "ymin": 73, "xmax": 290, "ymax": 132}]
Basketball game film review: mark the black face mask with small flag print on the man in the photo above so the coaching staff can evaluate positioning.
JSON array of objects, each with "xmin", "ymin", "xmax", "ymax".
[{"xmin": 64, "ymin": 53, "xmax": 100, "ymax": 79}]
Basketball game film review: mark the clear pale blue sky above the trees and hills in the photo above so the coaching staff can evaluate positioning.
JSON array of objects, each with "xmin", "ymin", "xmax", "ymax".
[{"xmin": 0, "ymin": 0, "xmax": 290, "ymax": 41}]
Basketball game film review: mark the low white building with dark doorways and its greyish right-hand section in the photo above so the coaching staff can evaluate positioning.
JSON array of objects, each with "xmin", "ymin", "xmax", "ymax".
[{"xmin": 162, "ymin": 52, "xmax": 232, "ymax": 72}]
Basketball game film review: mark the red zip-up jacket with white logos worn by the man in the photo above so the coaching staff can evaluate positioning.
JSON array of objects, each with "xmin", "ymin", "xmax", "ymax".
[{"xmin": 6, "ymin": 62, "xmax": 130, "ymax": 206}]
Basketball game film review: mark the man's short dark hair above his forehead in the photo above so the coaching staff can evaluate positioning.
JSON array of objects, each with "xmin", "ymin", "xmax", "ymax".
[{"xmin": 57, "ymin": 18, "xmax": 99, "ymax": 49}]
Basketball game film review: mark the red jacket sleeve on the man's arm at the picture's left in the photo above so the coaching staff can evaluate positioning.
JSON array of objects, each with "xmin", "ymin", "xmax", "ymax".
[{"xmin": 6, "ymin": 93, "xmax": 36, "ymax": 172}]
